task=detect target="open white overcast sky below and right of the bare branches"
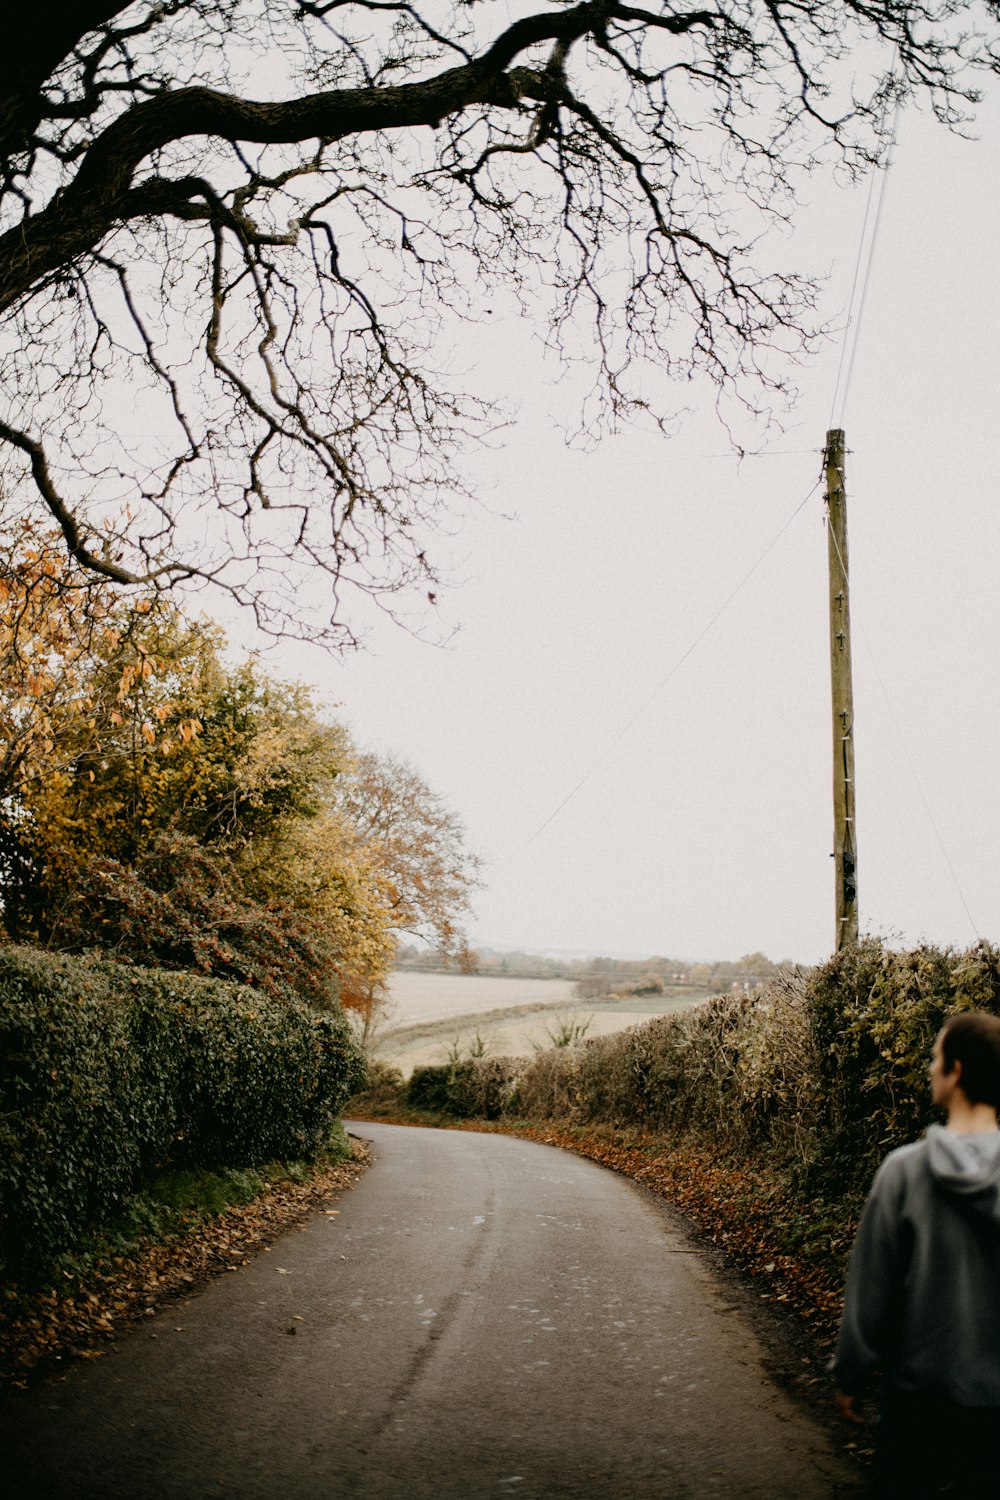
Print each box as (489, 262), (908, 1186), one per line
(230, 96), (1000, 962)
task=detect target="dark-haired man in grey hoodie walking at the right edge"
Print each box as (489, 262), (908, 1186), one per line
(832, 1011), (1000, 1500)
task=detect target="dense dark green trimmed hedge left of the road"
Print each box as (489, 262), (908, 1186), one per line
(0, 947), (364, 1274)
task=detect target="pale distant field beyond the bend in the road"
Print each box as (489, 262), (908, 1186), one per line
(373, 972), (708, 1074)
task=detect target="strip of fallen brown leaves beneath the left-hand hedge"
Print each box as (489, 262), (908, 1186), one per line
(0, 1142), (370, 1388)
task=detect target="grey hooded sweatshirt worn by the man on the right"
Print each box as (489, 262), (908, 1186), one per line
(832, 1125), (1000, 1407)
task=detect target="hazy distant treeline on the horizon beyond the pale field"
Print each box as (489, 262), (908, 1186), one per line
(396, 944), (799, 999)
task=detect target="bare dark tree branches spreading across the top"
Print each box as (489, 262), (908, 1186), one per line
(0, 0), (1000, 644)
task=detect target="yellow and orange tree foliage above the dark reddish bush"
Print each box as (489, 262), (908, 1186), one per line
(0, 527), (475, 1019)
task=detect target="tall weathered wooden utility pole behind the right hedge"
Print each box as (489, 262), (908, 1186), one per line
(826, 428), (858, 953)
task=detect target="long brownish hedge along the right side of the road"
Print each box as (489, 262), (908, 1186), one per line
(440, 939), (1000, 1203)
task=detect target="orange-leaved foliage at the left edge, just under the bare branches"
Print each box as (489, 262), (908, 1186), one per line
(0, 525), (226, 881)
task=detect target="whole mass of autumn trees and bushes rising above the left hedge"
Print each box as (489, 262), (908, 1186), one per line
(0, 531), (475, 1023)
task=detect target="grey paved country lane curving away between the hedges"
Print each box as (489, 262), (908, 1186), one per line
(0, 1125), (855, 1500)
